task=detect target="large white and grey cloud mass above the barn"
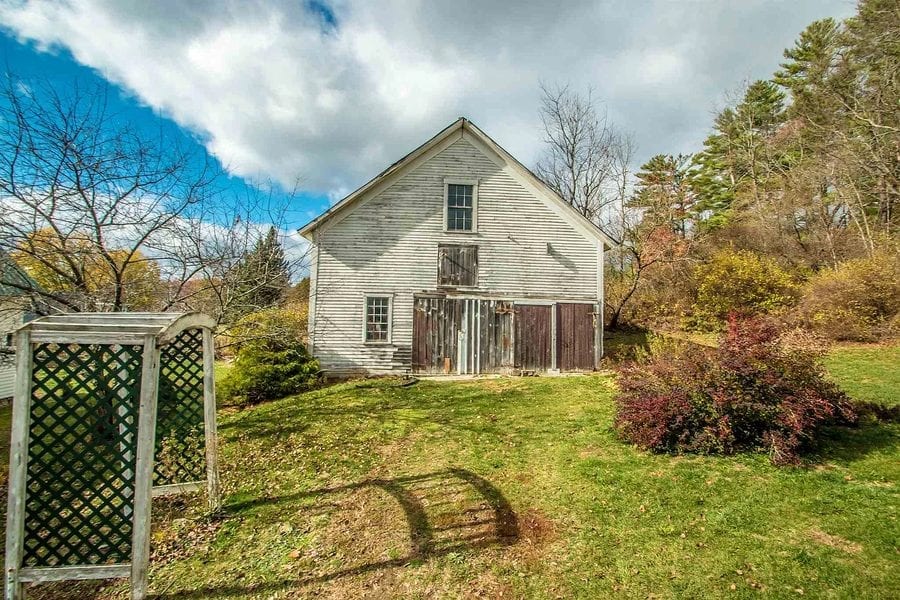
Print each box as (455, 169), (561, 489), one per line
(0, 0), (853, 197)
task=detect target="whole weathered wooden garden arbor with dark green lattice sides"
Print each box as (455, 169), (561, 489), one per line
(5, 313), (220, 600)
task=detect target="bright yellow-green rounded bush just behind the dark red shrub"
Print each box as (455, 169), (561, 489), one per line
(688, 250), (797, 331)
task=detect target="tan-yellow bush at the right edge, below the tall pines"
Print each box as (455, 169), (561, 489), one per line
(797, 252), (900, 341)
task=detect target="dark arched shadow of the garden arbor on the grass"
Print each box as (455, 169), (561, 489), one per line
(160, 468), (519, 598)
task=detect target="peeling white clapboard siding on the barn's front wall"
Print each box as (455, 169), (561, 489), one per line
(311, 134), (599, 374)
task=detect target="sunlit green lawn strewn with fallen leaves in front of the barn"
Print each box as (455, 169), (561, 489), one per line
(1, 352), (900, 598)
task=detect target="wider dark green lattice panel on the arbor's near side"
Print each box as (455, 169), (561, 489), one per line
(23, 344), (142, 566)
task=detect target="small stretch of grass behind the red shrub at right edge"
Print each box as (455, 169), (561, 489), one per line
(825, 345), (900, 406)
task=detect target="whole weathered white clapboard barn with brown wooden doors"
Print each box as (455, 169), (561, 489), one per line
(300, 118), (612, 376)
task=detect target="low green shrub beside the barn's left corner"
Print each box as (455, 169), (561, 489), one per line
(219, 308), (319, 404)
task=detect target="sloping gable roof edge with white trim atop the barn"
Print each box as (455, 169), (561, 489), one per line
(299, 117), (618, 247)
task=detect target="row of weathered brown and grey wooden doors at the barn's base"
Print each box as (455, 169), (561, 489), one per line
(412, 296), (596, 374)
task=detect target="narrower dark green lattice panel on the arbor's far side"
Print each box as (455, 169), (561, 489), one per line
(153, 329), (206, 485)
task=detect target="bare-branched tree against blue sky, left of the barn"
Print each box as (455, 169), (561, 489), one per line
(0, 76), (304, 320)
